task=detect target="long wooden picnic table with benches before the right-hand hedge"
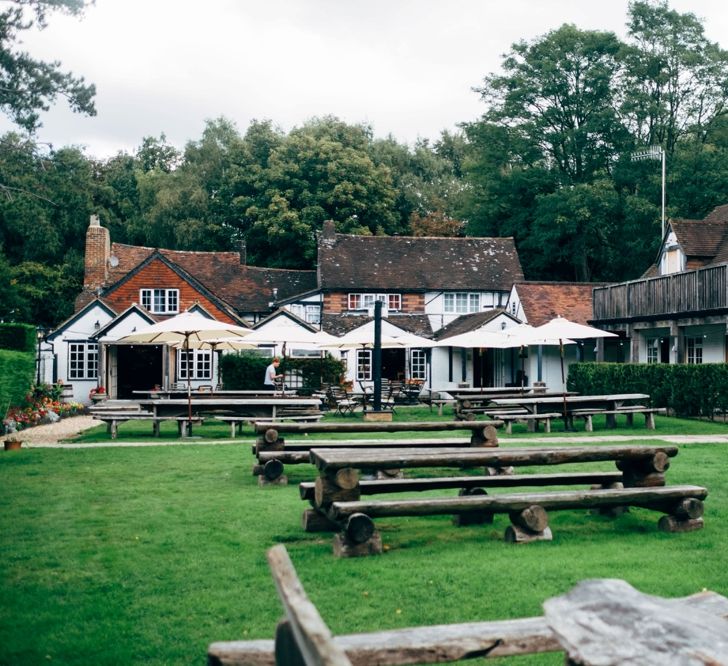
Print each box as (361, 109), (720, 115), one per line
(492, 393), (664, 431)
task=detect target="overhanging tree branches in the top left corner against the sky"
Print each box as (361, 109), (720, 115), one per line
(0, 0), (96, 132)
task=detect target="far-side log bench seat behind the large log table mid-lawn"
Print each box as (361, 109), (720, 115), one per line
(298, 472), (623, 501)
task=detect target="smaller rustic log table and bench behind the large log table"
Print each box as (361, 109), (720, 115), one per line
(253, 421), (503, 485)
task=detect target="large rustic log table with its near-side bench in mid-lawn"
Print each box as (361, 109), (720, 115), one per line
(301, 445), (707, 557)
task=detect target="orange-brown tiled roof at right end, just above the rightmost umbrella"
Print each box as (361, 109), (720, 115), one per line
(515, 282), (607, 326)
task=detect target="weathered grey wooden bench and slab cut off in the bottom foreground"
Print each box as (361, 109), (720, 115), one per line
(207, 544), (728, 666)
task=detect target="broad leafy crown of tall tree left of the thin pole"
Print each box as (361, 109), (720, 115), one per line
(477, 25), (624, 185)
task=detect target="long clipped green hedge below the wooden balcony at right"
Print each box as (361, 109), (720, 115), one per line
(568, 363), (728, 418)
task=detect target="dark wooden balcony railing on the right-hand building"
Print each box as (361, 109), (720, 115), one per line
(593, 264), (728, 322)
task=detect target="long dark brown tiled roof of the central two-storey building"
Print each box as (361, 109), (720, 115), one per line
(318, 232), (523, 291)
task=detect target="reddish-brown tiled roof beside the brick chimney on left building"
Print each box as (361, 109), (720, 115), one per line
(110, 243), (316, 314)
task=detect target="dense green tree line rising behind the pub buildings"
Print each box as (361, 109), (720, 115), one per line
(0, 0), (728, 325)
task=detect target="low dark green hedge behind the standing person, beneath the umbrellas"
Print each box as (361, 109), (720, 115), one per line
(220, 352), (345, 395)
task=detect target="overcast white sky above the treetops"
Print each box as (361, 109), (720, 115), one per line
(0, 0), (728, 157)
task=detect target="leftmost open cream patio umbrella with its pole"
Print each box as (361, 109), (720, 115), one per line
(118, 312), (250, 428)
